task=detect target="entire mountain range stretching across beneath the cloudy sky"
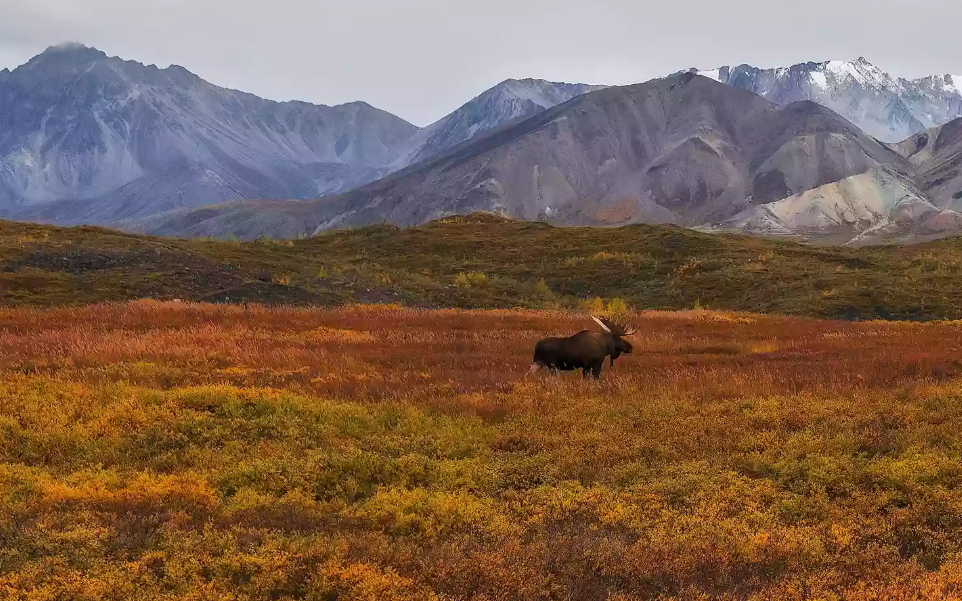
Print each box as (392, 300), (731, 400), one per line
(0, 46), (962, 244)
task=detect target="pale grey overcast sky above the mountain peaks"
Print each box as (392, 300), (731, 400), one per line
(0, 0), (962, 125)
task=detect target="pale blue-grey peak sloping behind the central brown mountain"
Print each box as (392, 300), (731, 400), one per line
(388, 79), (604, 171)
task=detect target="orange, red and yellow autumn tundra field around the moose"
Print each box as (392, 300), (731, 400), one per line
(0, 301), (962, 601)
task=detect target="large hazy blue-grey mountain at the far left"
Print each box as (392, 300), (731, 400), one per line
(0, 45), (417, 223)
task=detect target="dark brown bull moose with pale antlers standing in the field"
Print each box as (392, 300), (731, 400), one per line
(528, 316), (636, 380)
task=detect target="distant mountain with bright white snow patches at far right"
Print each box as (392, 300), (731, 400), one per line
(693, 58), (962, 142)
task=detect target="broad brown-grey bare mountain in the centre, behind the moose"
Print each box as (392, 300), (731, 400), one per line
(127, 73), (924, 240)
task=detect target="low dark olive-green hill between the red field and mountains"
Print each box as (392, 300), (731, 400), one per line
(0, 214), (962, 319)
